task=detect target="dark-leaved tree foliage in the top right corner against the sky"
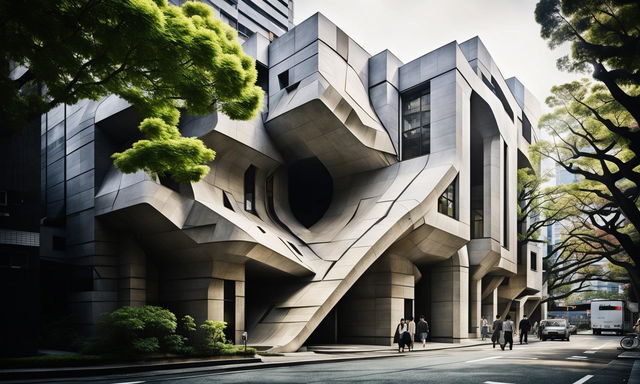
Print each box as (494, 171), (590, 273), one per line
(535, 0), (640, 147)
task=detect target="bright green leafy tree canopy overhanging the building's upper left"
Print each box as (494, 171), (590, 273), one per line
(0, 0), (263, 182)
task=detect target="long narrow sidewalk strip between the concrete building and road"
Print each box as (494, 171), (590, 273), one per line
(0, 339), (500, 380)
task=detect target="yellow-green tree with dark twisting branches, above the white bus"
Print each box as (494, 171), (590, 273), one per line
(532, 80), (640, 300)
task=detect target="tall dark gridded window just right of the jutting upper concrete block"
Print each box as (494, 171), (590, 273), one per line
(402, 86), (431, 160)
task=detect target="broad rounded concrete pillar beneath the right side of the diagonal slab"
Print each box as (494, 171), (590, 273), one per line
(337, 254), (419, 345)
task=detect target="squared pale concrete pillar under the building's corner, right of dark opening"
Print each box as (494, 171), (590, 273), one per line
(430, 247), (469, 343)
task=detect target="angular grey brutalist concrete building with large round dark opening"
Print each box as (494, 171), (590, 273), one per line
(41, 0), (543, 351)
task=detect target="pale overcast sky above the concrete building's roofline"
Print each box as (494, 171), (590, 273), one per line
(294, 0), (584, 110)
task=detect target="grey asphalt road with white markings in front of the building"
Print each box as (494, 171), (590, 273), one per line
(17, 335), (640, 384)
